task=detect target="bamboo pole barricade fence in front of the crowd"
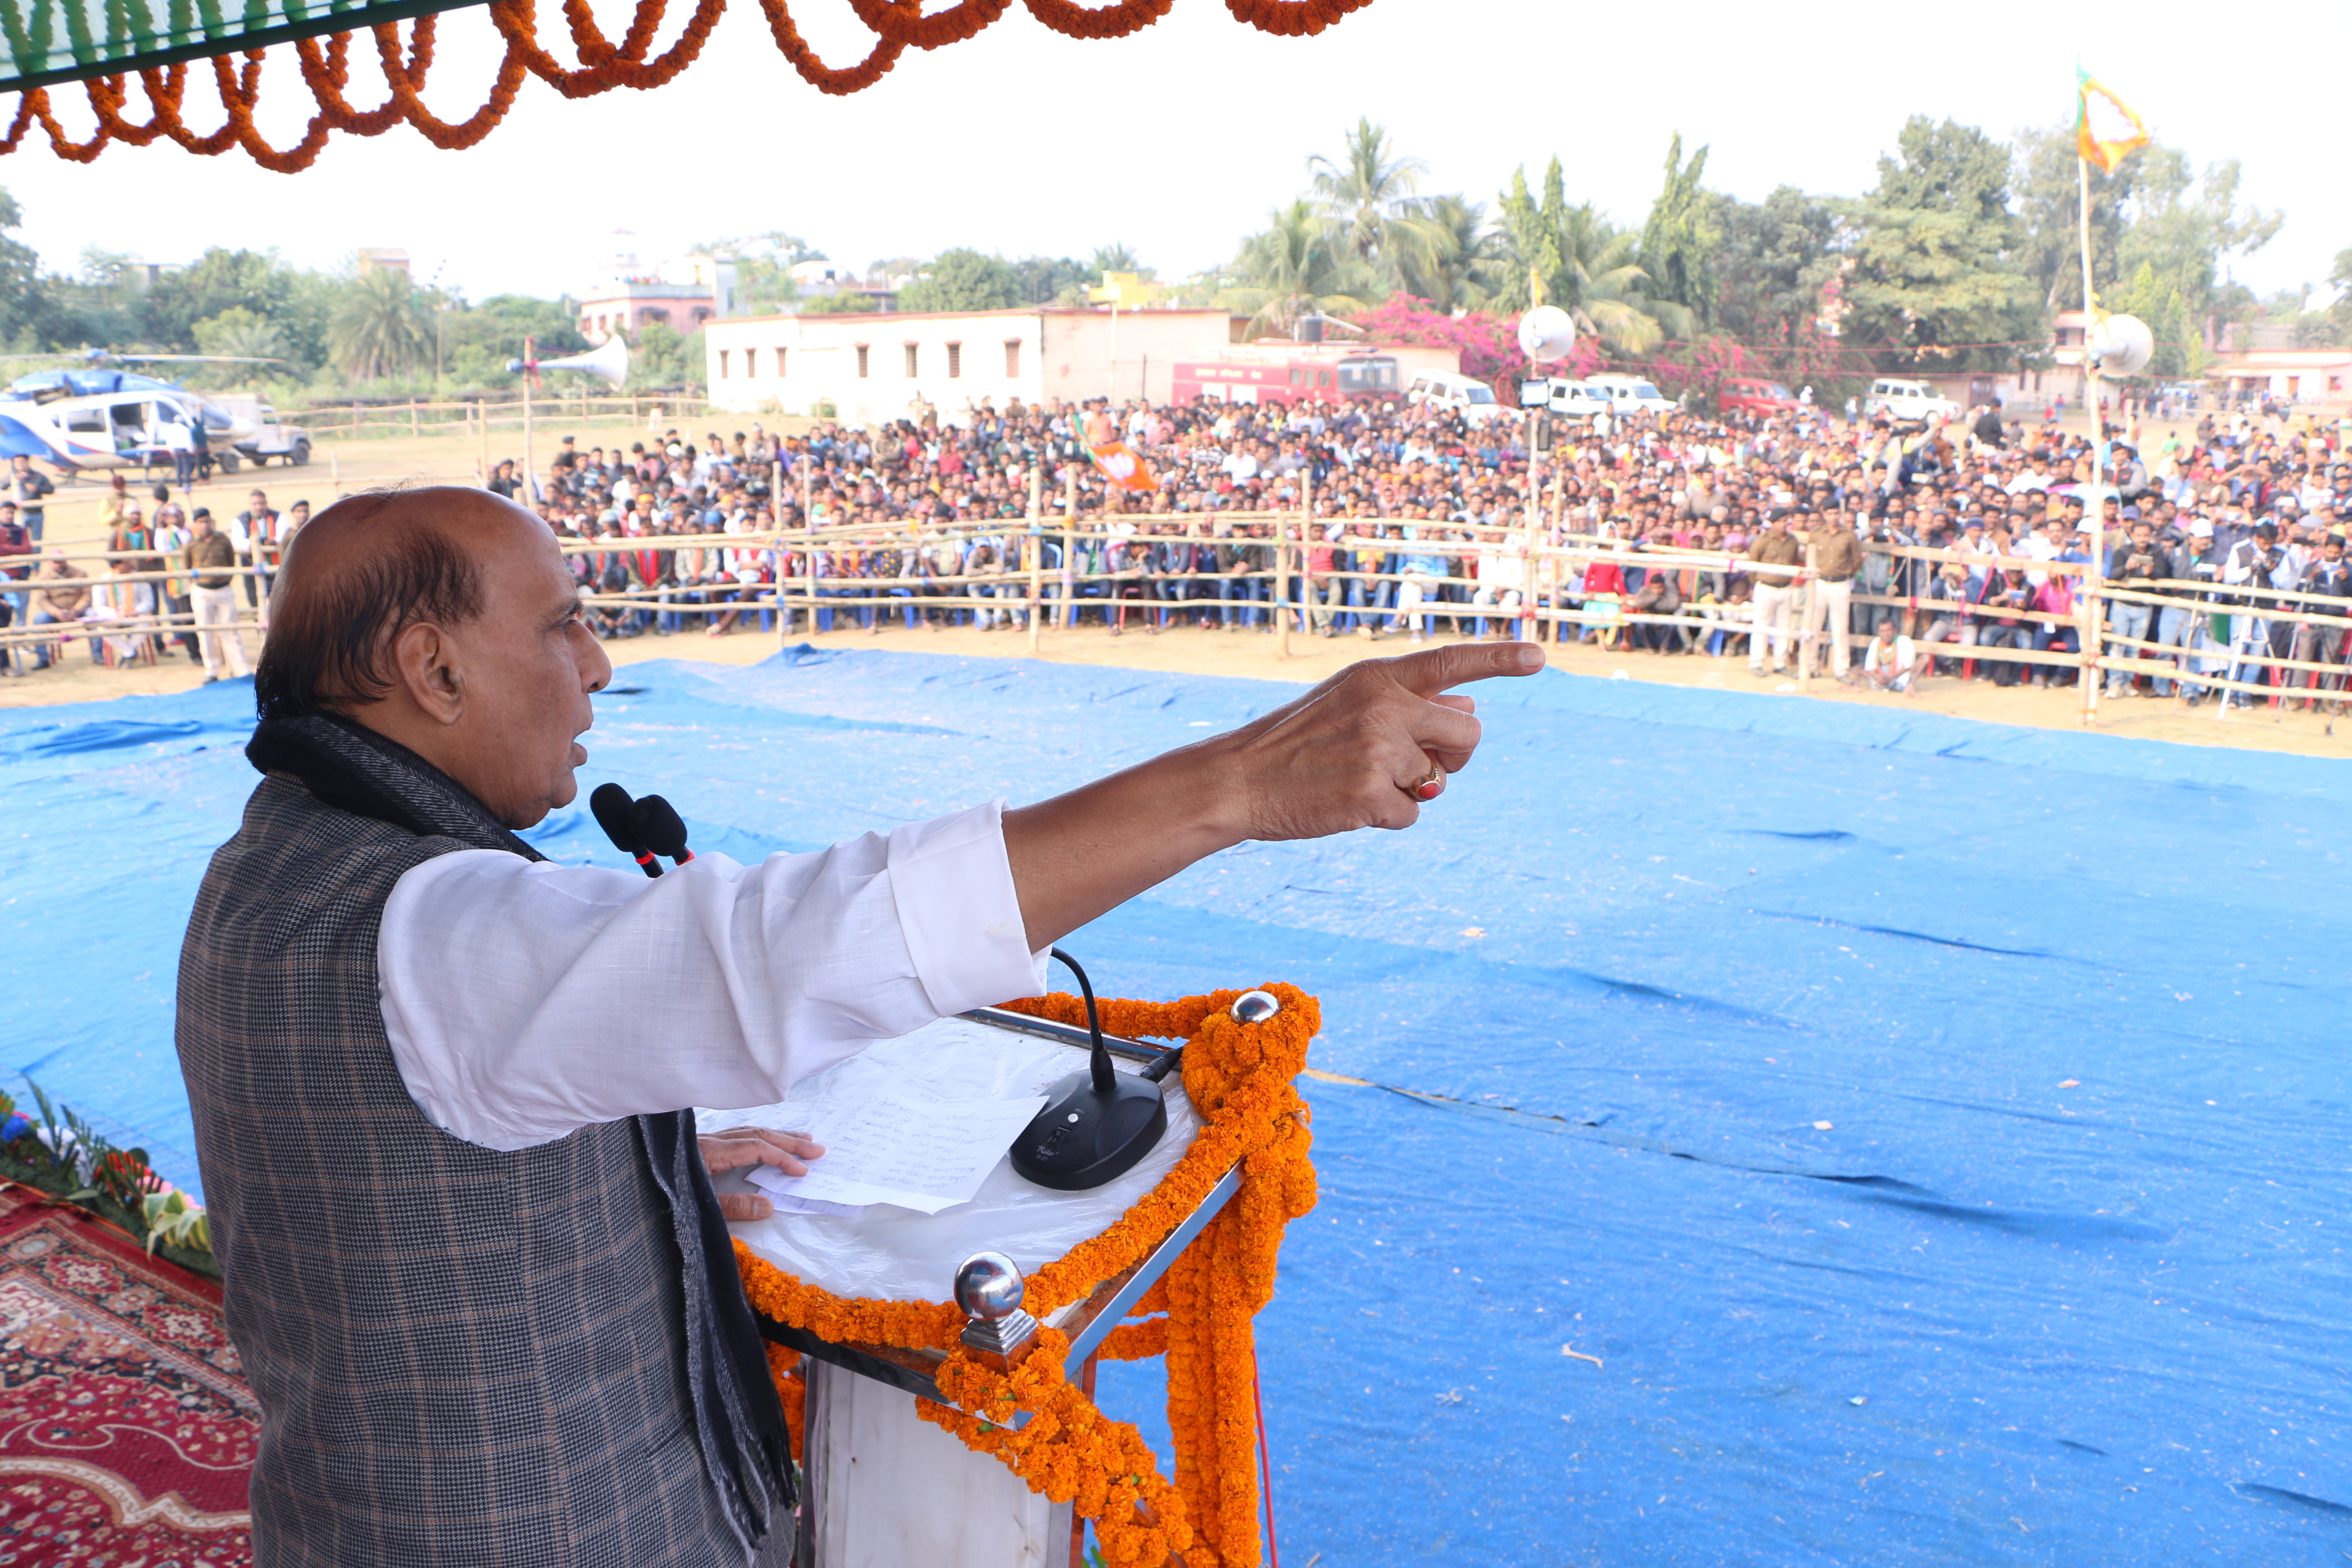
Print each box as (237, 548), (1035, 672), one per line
(18, 524), (2352, 701)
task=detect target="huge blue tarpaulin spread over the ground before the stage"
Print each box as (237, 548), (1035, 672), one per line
(0, 651), (2352, 1565)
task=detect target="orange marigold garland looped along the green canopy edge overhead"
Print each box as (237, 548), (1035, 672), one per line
(0, 0), (1371, 174)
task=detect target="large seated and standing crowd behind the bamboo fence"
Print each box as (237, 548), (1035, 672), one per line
(0, 400), (2352, 703)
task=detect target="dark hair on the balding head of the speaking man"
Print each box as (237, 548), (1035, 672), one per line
(254, 494), (482, 720)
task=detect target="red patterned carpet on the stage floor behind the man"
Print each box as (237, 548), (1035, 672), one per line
(0, 1185), (257, 1568)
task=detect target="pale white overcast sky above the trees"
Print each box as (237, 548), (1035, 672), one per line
(0, 0), (2352, 310)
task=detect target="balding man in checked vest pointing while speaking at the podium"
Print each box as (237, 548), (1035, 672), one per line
(179, 489), (1543, 1568)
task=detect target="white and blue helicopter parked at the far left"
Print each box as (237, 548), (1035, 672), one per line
(0, 348), (290, 473)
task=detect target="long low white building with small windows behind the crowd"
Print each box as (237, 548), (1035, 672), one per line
(703, 306), (1239, 426)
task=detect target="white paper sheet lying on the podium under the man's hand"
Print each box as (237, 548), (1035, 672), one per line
(750, 1095), (1044, 1213)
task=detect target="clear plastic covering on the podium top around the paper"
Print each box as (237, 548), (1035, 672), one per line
(696, 1018), (1199, 1302)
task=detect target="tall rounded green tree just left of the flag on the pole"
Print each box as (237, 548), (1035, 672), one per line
(1844, 115), (2039, 369)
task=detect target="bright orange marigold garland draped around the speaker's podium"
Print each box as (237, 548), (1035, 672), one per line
(736, 983), (1322, 1568)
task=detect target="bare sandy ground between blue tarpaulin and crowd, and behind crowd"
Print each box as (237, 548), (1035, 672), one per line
(0, 416), (2352, 757)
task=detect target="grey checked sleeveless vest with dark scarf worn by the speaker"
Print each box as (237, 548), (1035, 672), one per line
(179, 720), (792, 1568)
